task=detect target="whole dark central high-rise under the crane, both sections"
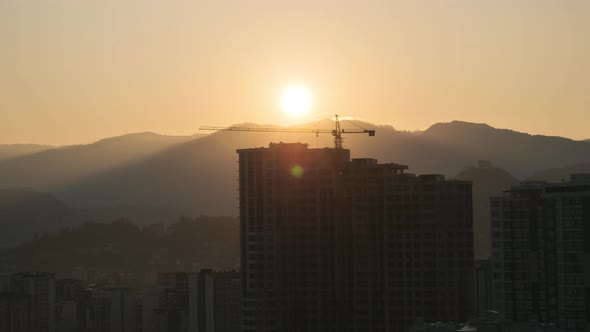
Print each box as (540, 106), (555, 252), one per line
(238, 143), (473, 331)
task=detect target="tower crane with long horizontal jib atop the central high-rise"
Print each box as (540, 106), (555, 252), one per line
(199, 114), (375, 149)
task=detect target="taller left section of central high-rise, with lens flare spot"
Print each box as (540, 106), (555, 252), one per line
(238, 144), (350, 331)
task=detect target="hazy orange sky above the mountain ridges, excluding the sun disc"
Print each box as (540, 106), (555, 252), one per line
(0, 0), (590, 144)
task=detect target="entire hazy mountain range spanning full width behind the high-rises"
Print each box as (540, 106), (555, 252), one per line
(0, 120), (590, 249)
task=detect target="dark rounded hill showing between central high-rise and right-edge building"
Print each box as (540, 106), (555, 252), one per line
(455, 161), (519, 259)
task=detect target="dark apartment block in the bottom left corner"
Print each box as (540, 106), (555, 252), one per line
(10, 272), (55, 332)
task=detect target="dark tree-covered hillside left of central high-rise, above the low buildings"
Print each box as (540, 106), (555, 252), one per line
(1, 216), (239, 272)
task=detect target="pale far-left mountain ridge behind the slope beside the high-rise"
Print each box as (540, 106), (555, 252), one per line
(0, 133), (201, 191)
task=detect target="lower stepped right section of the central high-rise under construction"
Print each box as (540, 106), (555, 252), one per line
(343, 159), (474, 331)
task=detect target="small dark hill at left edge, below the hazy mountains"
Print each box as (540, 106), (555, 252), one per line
(0, 189), (72, 246)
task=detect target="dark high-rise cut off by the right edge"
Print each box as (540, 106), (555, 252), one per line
(491, 175), (590, 331)
